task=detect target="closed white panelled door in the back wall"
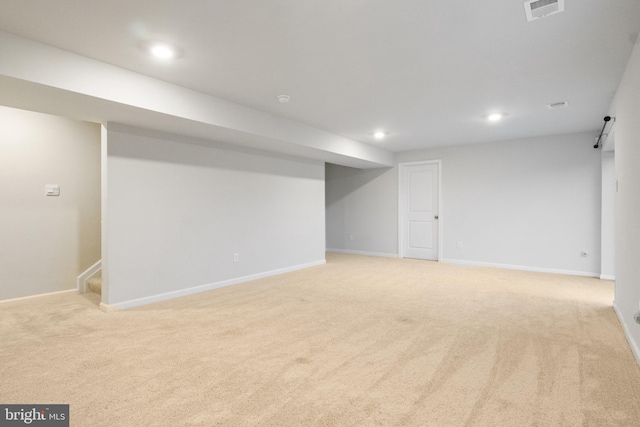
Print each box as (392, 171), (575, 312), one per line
(399, 162), (440, 261)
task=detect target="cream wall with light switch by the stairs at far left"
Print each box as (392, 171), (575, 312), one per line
(0, 107), (100, 300)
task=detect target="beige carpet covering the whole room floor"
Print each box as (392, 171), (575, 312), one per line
(0, 254), (640, 427)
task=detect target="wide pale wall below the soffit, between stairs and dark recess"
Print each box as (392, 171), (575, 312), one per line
(103, 124), (325, 307)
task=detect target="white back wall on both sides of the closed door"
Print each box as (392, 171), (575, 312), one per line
(327, 133), (601, 276)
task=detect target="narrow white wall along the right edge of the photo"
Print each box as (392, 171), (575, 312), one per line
(610, 38), (640, 363)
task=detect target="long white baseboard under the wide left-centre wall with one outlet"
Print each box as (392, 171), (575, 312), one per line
(100, 259), (327, 312)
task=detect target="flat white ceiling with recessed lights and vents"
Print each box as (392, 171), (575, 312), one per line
(0, 0), (640, 152)
